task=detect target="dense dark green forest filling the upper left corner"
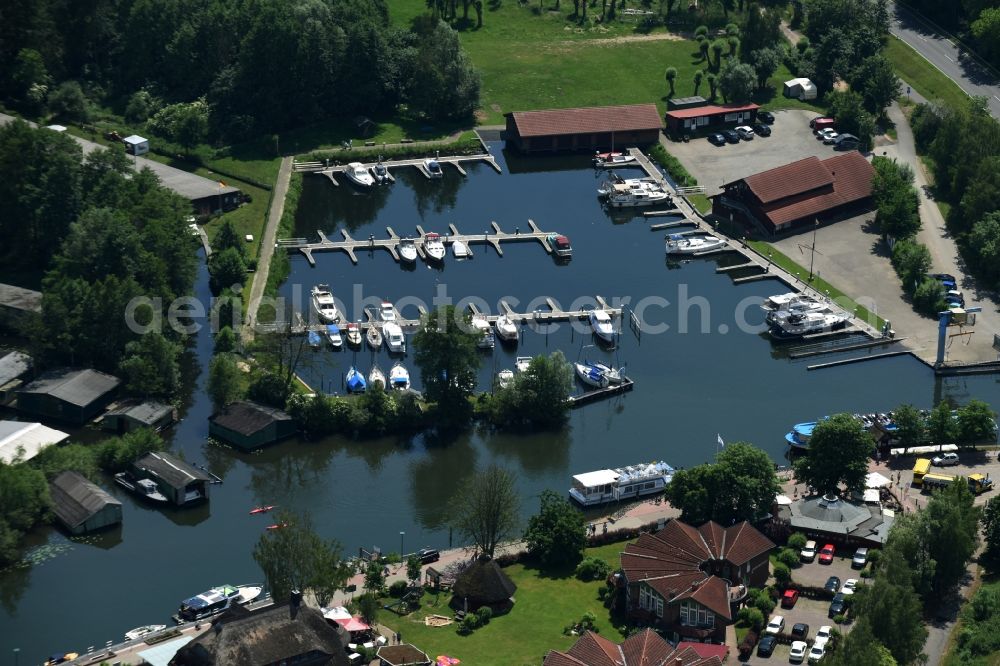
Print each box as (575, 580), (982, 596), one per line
(0, 0), (479, 140)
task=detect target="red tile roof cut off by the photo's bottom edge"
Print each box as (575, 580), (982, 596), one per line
(542, 629), (725, 666)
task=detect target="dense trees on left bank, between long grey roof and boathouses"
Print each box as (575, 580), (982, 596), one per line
(0, 121), (197, 397)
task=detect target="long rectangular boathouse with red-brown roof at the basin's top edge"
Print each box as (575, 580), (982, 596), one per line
(505, 104), (663, 153)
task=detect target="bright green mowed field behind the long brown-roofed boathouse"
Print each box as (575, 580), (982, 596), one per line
(389, 0), (814, 124)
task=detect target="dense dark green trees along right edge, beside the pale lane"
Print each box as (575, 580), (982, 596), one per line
(911, 97), (1000, 288)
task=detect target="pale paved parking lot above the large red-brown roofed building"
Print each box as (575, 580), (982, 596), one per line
(666, 110), (837, 195)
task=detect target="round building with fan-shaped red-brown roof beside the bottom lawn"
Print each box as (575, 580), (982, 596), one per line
(621, 520), (774, 643)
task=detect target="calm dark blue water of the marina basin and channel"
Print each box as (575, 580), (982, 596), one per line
(0, 146), (1000, 664)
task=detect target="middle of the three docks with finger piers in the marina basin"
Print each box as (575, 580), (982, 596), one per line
(276, 220), (559, 266)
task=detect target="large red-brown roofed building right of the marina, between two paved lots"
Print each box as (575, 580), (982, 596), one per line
(712, 151), (875, 234)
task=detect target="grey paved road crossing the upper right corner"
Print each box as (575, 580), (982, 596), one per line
(890, 4), (1000, 117)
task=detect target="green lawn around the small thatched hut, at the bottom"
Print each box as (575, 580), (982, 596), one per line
(379, 543), (625, 666)
